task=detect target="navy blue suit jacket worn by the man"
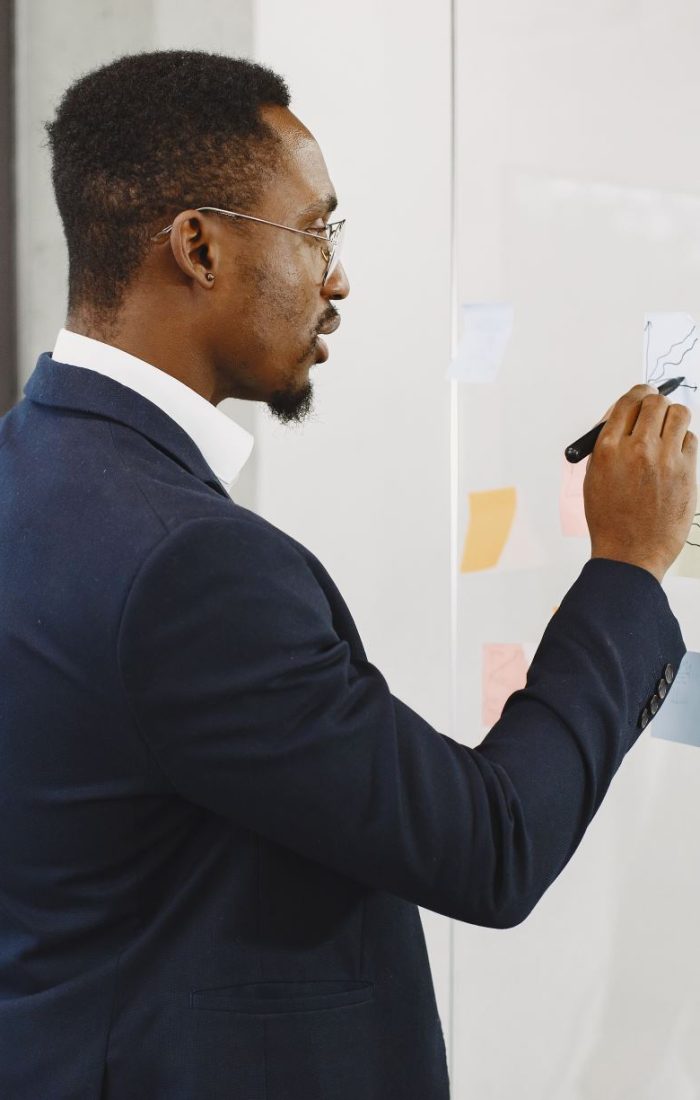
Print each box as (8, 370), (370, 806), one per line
(0, 354), (685, 1100)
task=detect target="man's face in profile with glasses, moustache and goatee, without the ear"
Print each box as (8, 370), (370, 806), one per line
(207, 107), (350, 422)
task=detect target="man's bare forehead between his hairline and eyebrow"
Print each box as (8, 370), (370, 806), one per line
(260, 107), (333, 216)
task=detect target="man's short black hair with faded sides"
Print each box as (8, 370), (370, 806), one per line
(44, 50), (289, 323)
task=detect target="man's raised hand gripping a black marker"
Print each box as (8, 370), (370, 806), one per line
(583, 385), (698, 581)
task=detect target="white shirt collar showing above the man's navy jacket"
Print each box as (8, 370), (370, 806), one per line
(52, 329), (254, 495)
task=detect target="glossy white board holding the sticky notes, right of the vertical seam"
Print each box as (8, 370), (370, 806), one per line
(450, 0), (700, 1100)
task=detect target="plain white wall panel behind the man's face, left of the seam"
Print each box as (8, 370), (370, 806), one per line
(255, 0), (451, 1069)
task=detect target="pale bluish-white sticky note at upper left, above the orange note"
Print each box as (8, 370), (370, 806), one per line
(447, 303), (513, 382)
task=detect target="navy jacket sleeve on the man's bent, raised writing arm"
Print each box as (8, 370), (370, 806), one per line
(118, 518), (685, 928)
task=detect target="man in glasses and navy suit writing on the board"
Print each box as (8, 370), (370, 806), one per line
(0, 51), (697, 1100)
